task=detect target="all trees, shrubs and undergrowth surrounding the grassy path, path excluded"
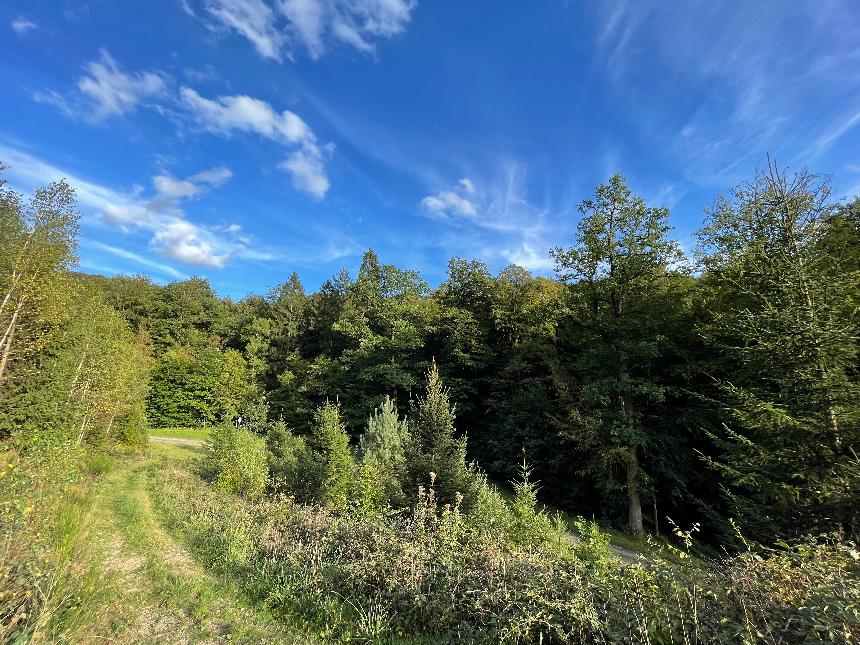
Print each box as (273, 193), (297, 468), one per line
(0, 159), (860, 643)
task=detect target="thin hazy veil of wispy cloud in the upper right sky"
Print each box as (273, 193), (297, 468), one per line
(595, 0), (860, 185)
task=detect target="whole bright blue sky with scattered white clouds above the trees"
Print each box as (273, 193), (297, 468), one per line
(0, 0), (860, 297)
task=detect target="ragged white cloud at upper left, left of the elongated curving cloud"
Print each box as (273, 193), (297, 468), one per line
(33, 49), (167, 121)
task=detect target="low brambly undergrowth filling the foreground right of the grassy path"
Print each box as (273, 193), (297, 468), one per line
(151, 458), (860, 643)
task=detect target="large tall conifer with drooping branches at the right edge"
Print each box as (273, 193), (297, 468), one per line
(699, 160), (860, 539)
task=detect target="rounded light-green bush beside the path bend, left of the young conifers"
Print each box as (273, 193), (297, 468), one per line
(209, 424), (269, 499)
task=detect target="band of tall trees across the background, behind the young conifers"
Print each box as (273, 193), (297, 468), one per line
(0, 164), (860, 544)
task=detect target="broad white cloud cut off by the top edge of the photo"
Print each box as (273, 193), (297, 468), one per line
(196, 0), (424, 61)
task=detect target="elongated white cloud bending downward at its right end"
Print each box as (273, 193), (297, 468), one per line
(179, 87), (333, 199)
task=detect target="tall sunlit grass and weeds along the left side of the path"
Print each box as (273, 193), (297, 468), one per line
(0, 446), (113, 643)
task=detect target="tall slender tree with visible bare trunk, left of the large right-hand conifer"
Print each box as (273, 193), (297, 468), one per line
(553, 175), (683, 535)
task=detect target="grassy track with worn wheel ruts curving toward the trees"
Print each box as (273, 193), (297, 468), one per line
(92, 445), (301, 643)
